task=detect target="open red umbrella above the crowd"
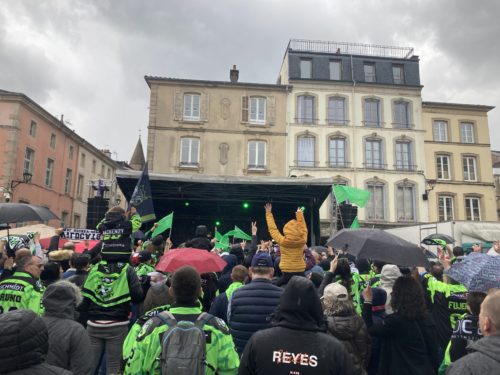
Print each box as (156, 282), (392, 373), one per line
(156, 247), (226, 273)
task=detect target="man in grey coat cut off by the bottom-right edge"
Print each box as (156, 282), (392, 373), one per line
(446, 290), (500, 375)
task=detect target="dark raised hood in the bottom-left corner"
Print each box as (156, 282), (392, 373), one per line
(0, 310), (49, 373)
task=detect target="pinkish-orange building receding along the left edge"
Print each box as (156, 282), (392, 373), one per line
(0, 90), (116, 227)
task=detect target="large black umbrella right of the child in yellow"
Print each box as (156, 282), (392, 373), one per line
(326, 228), (429, 267)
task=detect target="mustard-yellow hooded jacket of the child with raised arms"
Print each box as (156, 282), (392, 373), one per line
(266, 211), (307, 272)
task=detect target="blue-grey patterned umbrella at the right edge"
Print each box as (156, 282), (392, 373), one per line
(445, 253), (500, 293)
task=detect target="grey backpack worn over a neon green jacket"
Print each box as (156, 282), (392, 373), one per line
(156, 311), (213, 375)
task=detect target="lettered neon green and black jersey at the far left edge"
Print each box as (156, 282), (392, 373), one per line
(0, 272), (44, 315)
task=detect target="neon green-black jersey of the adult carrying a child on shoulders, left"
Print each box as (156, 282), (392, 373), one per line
(82, 260), (130, 307)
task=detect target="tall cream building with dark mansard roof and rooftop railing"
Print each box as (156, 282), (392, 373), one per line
(278, 40), (428, 231)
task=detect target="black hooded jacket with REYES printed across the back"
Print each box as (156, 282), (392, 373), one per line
(238, 276), (353, 375)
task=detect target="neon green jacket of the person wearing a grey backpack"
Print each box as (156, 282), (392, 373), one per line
(124, 307), (240, 375)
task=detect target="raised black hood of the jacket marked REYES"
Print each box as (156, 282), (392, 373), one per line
(274, 276), (325, 331)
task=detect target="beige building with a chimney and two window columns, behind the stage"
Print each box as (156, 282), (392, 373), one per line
(146, 67), (290, 177)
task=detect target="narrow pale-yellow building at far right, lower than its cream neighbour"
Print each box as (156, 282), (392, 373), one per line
(422, 102), (498, 222)
